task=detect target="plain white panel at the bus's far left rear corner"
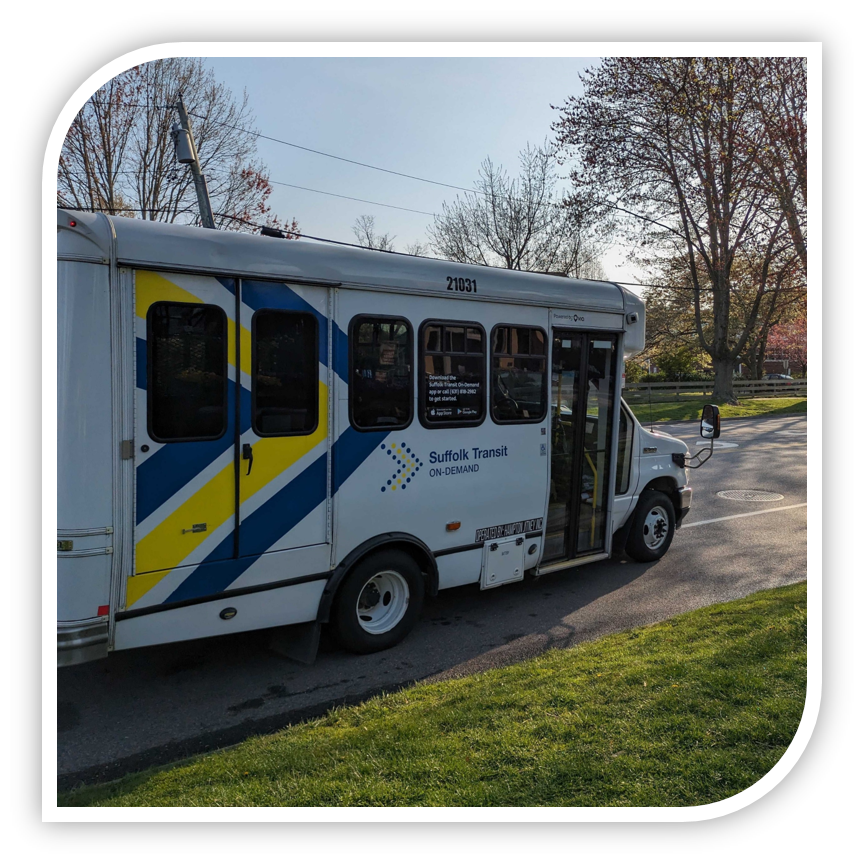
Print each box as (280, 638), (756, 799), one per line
(57, 261), (113, 621)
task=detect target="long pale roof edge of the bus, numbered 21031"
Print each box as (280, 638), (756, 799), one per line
(57, 209), (644, 318)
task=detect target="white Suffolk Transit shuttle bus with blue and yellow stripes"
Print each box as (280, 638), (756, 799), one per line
(57, 210), (719, 665)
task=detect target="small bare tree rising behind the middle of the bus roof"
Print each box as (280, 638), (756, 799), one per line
(428, 142), (602, 275)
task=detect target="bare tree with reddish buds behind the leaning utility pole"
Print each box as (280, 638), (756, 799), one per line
(57, 57), (298, 232)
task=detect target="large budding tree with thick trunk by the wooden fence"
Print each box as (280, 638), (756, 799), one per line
(554, 57), (808, 402)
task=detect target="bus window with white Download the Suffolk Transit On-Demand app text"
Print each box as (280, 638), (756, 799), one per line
(420, 321), (486, 428)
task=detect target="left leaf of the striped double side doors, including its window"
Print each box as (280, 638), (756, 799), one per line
(125, 270), (237, 608)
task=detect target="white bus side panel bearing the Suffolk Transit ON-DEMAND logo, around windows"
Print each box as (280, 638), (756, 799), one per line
(334, 289), (548, 587)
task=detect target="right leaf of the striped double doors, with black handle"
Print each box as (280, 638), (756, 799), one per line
(238, 279), (330, 556)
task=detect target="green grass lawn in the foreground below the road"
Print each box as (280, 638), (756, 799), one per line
(59, 583), (806, 807)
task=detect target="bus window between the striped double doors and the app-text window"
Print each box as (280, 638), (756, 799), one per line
(348, 315), (414, 431)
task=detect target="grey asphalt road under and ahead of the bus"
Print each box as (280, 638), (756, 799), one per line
(57, 415), (807, 788)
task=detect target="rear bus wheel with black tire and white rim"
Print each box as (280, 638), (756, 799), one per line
(330, 549), (423, 654)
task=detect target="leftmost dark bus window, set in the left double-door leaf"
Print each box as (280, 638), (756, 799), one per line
(147, 303), (228, 441)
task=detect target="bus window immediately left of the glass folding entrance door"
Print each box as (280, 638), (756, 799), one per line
(490, 324), (546, 423)
